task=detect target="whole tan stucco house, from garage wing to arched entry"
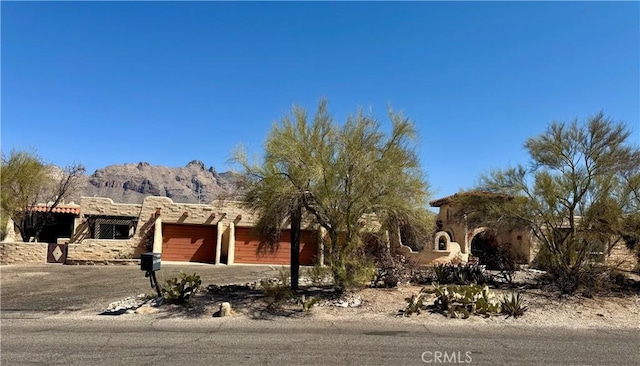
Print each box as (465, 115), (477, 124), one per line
(0, 193), (638, 269)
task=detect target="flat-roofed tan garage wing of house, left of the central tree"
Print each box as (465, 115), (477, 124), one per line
(0, 196), (322, 265)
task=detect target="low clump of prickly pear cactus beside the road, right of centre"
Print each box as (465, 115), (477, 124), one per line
(432, 284), (502, 319)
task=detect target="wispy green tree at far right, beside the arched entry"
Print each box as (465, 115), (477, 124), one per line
(470, 113), (640, 293)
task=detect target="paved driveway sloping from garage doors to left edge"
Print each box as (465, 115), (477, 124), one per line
(0, 262), (279, 318)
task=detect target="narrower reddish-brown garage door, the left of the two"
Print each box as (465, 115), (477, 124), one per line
(162, 224), (217, 263)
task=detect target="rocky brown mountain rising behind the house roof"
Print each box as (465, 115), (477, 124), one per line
(74, 160), (237, 203)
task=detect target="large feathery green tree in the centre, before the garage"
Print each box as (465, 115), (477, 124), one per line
(234, 100), (432, 289)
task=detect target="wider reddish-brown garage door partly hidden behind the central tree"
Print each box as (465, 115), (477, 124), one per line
(234, 227), (318, 266)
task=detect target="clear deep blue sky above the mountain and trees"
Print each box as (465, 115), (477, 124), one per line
(1, 1), (640, 200)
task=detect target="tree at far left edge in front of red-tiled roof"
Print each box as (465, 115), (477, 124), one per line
(0, 151), (85, 241)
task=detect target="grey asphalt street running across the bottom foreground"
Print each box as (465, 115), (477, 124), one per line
(1, 316), (640, 365)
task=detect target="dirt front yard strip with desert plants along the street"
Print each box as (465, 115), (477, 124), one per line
(160, 278), (640, 329)
